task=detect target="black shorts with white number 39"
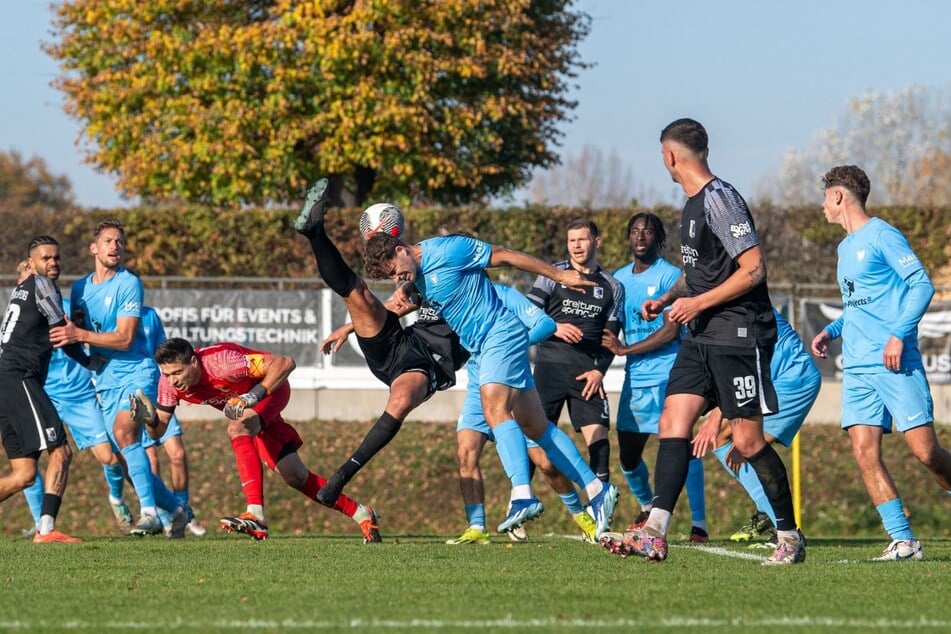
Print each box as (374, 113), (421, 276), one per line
(667, 339), (779, 419)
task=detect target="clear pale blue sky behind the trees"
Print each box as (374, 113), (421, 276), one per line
(0, 0), (951, 208)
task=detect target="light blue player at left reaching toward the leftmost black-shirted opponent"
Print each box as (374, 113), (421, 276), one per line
(50, 219), (191, 539)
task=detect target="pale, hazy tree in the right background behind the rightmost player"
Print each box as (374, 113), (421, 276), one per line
(754, 86), (951, 206)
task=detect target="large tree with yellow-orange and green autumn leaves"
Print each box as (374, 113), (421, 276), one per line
(46, 0), (590, 205)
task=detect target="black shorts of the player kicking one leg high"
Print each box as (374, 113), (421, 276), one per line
(357, 311), (439, 398)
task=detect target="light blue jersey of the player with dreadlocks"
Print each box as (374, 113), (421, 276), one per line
(614, 258), (683, 387)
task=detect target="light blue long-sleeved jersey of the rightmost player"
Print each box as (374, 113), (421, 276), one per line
(827, 218), (934, 373)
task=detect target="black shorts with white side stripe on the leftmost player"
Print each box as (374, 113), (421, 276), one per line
(0, 376), (66, 459)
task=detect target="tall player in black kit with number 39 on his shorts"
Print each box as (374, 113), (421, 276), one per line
(602, 119), (806, 564)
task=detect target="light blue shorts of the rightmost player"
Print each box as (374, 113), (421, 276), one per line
(842, 368), (934, 434)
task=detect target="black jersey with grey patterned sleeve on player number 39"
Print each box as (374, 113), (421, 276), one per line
(680, 178), (776, 347)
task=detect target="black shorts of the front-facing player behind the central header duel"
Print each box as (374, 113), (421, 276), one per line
(534, 363), (611, 431)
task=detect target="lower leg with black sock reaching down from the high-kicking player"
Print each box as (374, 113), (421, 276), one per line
(317, 371), (432, 506)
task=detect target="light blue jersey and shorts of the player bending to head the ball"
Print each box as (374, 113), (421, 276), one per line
(416, 236), (535, 390)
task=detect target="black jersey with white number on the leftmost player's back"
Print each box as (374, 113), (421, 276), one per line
(0, 275), (66, 383)
